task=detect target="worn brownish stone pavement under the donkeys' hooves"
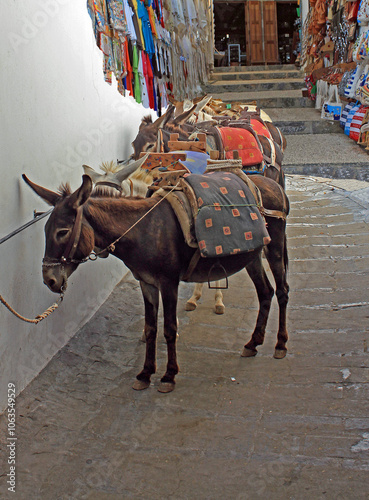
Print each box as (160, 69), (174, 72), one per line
(0, 175), (369, 500)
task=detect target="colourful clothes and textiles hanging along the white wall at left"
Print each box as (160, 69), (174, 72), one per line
(87, 0), (213, 110)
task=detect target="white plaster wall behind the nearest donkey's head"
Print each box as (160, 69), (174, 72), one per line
(0, 0), (154, 411)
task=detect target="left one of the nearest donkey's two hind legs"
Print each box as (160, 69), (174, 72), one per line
(241, 255), (274, 358)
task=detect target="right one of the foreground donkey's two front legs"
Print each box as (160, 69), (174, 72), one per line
(158, 283), (179, 392)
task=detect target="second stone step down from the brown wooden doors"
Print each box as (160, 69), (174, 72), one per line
(204, 78), (304, 94)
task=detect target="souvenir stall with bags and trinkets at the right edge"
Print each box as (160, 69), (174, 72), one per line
(301, 0), (369, 149)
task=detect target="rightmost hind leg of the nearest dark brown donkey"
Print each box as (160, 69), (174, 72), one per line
(265, 229), (289, 359)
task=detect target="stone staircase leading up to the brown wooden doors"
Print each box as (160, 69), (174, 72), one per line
(203, 64), (369, 180)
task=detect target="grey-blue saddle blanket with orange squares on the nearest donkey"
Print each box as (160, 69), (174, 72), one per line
(184, 172), (270, 257)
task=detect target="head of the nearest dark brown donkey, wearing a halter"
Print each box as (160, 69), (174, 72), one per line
(22, 174), (95, 293)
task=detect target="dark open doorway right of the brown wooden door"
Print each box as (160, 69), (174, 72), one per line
(277, 2), (299, 64)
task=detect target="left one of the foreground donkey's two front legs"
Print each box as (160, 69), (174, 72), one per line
(133, 281), (159, 391)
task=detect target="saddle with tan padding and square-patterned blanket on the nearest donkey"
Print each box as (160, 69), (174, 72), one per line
(151, 160), (270, 257)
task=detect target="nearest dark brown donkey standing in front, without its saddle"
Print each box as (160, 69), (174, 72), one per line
(23, 175), (288, 392)
